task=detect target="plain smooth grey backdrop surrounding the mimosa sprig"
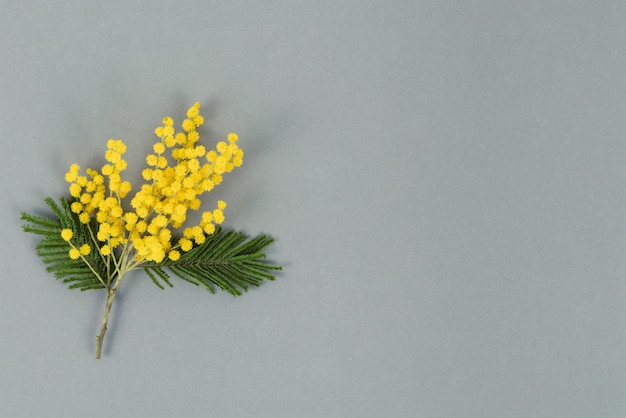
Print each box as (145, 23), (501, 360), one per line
(0, 0), (626, 417)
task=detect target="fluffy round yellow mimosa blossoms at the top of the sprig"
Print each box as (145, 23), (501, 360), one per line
(62, 103), (243, 263)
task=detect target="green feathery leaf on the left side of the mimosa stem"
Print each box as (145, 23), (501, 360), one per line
(21, 197), (106, 291)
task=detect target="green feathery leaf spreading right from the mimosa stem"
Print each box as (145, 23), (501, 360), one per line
(144, 228), (282, 296)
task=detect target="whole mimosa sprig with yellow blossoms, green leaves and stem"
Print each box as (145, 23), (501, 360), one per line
(22, 103), (281, 359)
